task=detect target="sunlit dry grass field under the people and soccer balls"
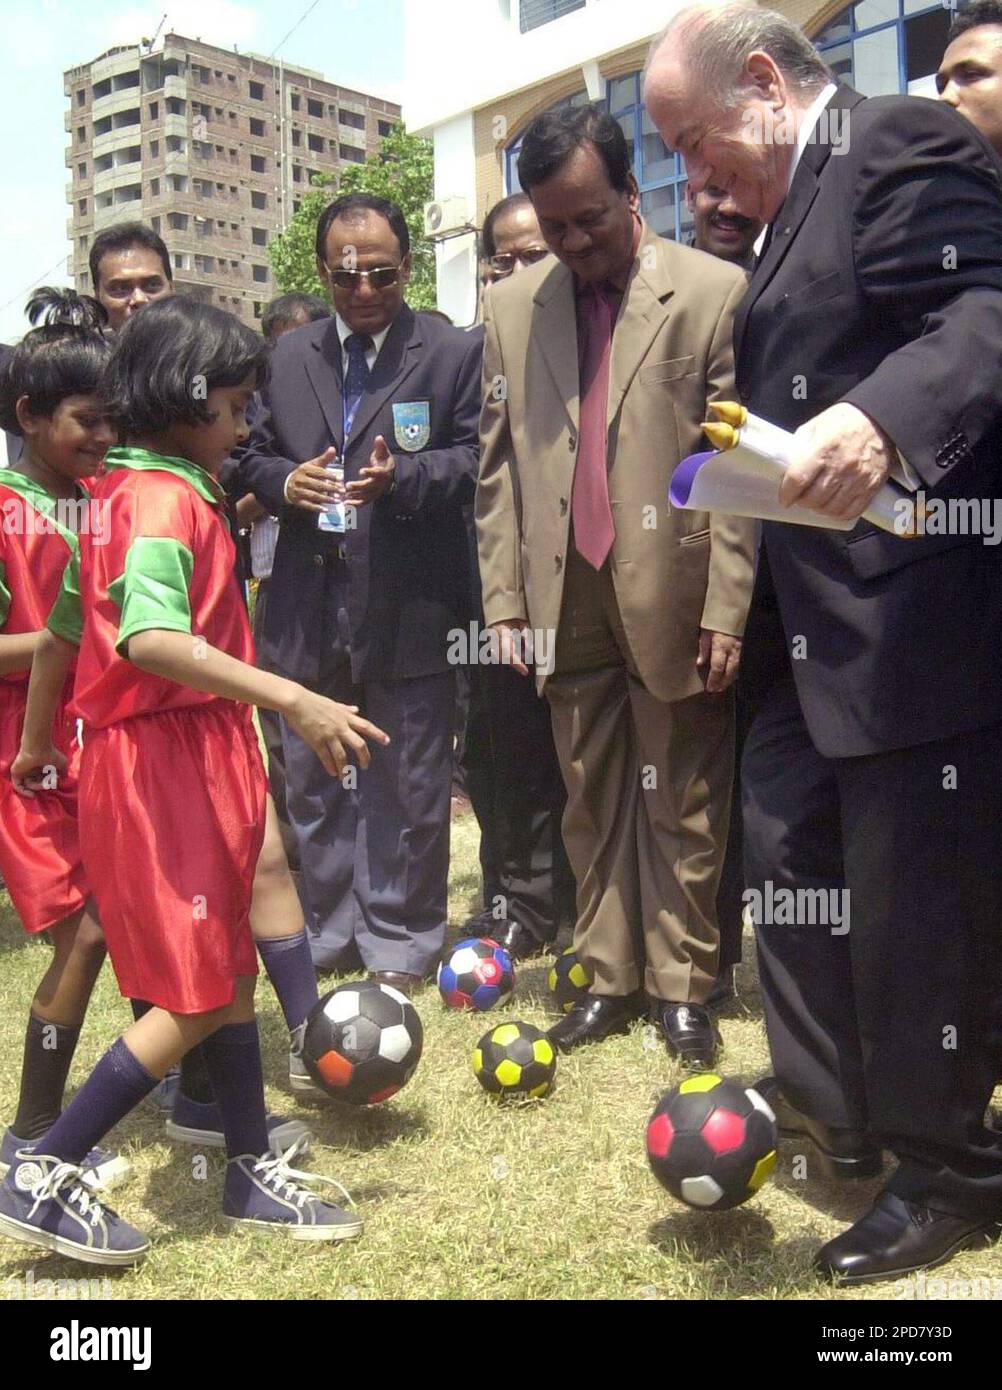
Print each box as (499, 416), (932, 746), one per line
(0, 816), (1002, 1300)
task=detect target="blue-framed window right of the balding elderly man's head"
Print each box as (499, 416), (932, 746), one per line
(814, 0), (953, 96)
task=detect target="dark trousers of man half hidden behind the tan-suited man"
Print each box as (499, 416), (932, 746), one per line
(463, 666), (575, 942)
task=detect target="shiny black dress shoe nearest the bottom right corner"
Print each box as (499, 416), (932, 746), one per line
(814, 1191), (999, 1284)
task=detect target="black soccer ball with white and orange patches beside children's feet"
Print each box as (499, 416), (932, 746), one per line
(303, 980), (424, 1105)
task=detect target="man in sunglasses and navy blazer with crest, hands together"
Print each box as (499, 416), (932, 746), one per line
(240, 193), (481, 988)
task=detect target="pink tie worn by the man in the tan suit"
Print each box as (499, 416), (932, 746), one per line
(571, 286), (616, 570)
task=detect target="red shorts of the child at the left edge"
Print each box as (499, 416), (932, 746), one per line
(0, 681), (89, 931)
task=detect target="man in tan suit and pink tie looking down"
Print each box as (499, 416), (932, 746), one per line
(477, 107), (752, 1065)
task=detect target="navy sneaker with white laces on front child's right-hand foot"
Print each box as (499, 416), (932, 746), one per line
(222, 1144), (363, 1240)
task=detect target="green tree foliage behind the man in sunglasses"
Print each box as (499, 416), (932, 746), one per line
(268, 122), (435, 309)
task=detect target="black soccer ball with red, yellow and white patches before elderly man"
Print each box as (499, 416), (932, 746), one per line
(648, 1072), (777, 1211)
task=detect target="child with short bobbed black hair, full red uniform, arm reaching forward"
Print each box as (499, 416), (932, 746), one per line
(0, 296), (388, 1265)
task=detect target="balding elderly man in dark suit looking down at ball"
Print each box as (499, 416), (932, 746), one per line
(646, 4), (1002, 1283)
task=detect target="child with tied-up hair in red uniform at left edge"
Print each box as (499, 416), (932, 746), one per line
(0, 289), (128, 1186)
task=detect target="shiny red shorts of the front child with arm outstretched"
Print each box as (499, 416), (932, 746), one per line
(81, 701), (267, 1013)
